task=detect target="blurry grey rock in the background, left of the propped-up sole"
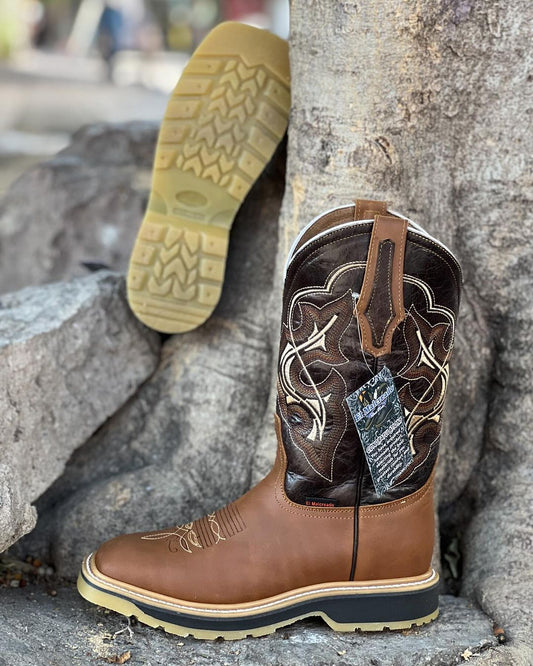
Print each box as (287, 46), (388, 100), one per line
(0, 122), (157, 293)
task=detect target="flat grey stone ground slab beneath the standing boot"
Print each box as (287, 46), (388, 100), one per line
(0, 585), (496, 666)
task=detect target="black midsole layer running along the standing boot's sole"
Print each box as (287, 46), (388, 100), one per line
(82, 573), (439, 631)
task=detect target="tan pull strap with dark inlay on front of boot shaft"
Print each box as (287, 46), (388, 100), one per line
(356, 215), (409, 357)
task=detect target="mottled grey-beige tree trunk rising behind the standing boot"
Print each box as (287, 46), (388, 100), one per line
(264, 0), (533, 663)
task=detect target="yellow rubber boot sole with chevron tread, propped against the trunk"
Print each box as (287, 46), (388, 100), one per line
(127, 23), (290, 333)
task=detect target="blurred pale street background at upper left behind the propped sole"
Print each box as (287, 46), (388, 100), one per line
(0, 0), (289, 197)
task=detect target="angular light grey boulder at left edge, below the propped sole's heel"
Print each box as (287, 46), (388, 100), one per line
(0, 272), (159, 552)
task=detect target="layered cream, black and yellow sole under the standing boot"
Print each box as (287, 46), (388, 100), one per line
(78, 556), (439, 640)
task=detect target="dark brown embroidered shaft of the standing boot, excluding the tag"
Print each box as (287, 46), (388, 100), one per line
(277, 201), (461, 506)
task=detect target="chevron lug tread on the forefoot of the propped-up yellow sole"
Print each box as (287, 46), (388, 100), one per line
(157, 56), (290, 197)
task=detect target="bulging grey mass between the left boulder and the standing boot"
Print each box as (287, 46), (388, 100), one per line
(12, 141), (284, 579)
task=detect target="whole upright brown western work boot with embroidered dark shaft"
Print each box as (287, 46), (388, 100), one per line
(78, 201), (461, 638)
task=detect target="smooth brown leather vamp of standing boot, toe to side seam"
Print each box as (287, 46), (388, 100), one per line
(95, 470), (353, 604)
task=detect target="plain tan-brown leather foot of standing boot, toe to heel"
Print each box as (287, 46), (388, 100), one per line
(95, 420), (434, 604)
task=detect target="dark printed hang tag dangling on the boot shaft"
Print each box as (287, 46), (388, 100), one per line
(346, 366), (413, 496)
